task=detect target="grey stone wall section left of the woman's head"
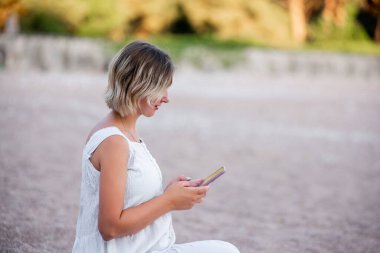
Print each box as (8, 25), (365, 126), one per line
(0, 35), (108, 72)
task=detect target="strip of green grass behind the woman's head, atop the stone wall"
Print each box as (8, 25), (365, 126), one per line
(108, 35), (380, 70)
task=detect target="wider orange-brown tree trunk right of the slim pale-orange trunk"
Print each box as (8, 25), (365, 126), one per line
(323, 0), (346, 26)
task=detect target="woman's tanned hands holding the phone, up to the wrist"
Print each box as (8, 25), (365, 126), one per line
(163, 176), (209, 210)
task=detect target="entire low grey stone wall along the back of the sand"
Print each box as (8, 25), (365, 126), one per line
(0, 35), (380, 78)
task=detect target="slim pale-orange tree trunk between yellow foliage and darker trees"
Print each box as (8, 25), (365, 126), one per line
(289, 0), (307, 43)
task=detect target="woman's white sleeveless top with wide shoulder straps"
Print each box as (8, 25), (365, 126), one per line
(72, 127), (175, 253)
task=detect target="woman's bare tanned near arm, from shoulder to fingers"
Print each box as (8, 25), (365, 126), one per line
(95, 136), (208, 240)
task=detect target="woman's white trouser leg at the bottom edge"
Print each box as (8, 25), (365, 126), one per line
(161, 240), (240, 253)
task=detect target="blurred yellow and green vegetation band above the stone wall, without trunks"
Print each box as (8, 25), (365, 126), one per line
(12, 0), (379, 55)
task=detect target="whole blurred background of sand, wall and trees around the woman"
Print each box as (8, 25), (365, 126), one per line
(0, 0), (380, 253)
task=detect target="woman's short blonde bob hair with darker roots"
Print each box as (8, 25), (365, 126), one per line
(105, 41), (174, 117)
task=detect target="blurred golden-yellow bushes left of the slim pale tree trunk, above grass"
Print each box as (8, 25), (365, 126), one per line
(15, 0), (290, 43)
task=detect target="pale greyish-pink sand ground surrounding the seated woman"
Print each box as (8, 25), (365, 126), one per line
(0, 68), (380, 253)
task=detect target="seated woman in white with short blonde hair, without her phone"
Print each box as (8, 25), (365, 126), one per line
(73, 42), (239, 253)
